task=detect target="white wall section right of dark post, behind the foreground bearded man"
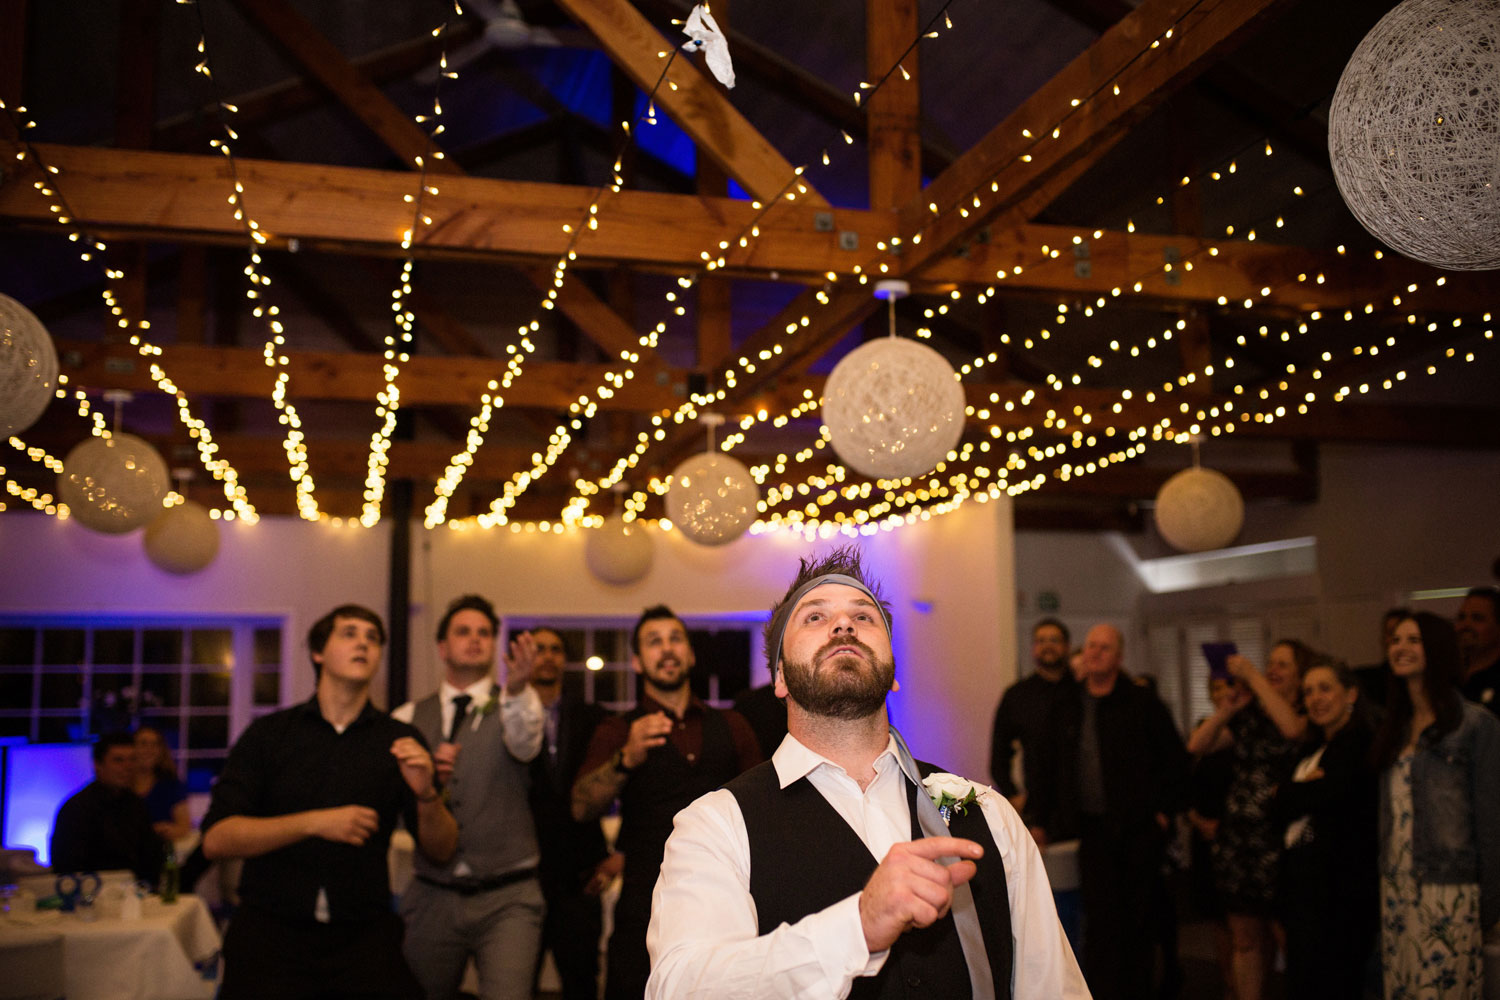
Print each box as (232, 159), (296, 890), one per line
(411, 501), (1016, 777)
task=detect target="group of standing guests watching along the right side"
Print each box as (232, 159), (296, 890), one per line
(992, 588), (1500, 1000)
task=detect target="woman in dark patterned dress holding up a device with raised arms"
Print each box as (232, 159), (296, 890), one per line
(1188, 639), (1313, 1000)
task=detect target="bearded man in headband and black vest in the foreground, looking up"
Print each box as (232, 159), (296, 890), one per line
(647, 547), (1089, 1000)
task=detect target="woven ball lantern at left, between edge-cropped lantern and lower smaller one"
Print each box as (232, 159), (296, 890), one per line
(57, 432), (170, 535)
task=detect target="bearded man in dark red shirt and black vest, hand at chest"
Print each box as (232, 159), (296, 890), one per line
(573, 604), (761, 1000)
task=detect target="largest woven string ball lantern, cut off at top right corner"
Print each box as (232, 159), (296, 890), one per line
(1328, 0), (1500, 270)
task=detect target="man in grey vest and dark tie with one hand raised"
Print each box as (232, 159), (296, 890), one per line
(392, 594), (545, 1000)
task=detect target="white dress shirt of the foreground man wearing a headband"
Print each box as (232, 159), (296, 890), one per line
(647, 736), (1089, 1000)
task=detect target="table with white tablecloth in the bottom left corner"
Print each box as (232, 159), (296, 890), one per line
(0, 895), (219, 1000)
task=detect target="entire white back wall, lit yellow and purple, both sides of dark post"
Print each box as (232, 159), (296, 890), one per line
(0, 501), (1016, 777)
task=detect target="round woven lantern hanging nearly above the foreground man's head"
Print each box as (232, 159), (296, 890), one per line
(824, 337), (965, 480)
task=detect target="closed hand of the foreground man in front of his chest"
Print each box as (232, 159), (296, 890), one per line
(860, 837), (984, 955)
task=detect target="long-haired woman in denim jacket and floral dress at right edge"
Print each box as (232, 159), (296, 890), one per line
(1374, 612), (1500, 1000)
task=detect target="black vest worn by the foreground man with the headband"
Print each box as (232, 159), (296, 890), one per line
(725, 762), (1016, 1000)
